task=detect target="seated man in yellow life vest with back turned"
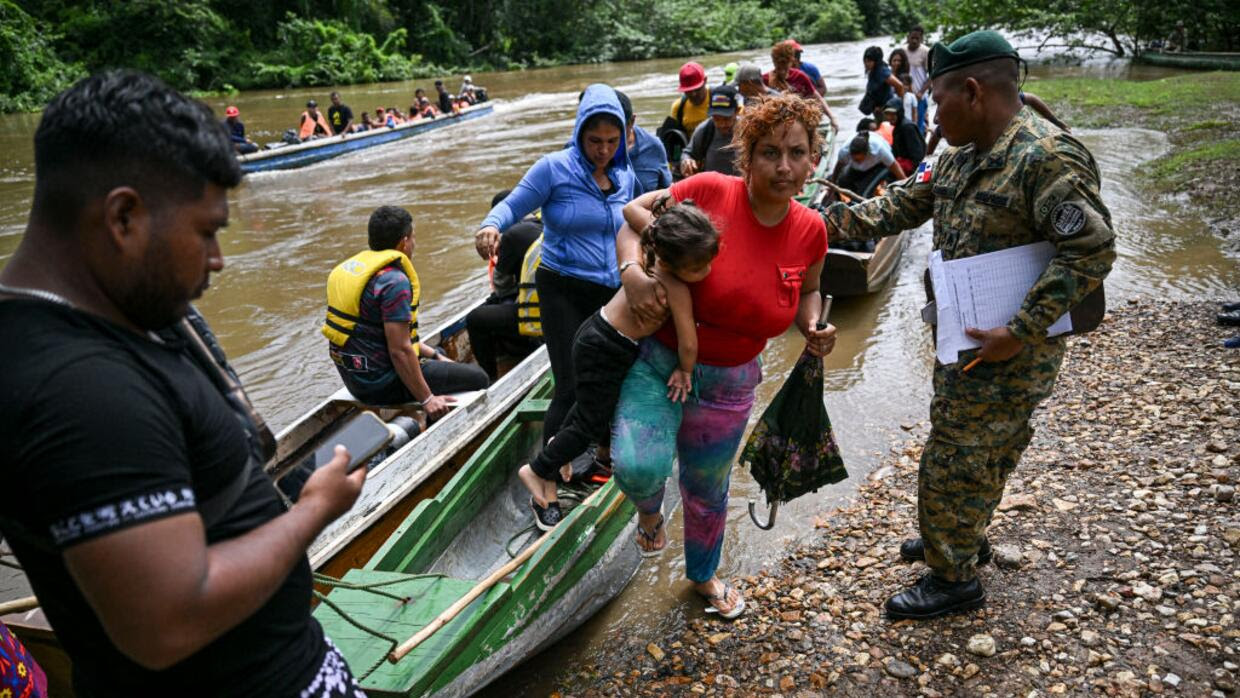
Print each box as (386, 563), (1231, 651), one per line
(322, 206), (490, 419)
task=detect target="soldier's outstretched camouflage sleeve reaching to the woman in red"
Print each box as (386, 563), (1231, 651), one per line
(822, 170), (934, 239)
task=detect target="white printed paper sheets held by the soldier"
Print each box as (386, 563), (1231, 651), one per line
(930, 242), (1073, 364)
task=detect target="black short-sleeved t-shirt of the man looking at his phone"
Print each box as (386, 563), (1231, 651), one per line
(0, 299), (325, 697)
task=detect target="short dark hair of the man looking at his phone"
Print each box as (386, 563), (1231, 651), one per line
(32, 71), (242, 231)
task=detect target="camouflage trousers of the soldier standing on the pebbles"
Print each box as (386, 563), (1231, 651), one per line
(918, 341), (1063, 581)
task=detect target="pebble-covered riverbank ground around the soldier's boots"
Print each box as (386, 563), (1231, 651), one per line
(562, 300), (1240, 698)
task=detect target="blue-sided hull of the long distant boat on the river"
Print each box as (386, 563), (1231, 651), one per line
(237, 103), (495, 174)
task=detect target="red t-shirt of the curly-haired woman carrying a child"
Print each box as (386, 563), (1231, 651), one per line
(656, 172), (827, 366)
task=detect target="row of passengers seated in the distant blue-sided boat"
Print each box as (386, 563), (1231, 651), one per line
(224, 76), (487, 155)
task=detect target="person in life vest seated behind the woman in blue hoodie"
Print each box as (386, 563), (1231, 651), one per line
(465, 190), (542, 381)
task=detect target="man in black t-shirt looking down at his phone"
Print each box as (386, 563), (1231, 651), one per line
(0, 71), (365, 698)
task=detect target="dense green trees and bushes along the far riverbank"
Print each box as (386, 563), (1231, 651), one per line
(0, 0), (1240, 112)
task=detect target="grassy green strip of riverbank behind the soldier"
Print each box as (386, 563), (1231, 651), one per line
(1025, 72), (1240, 250)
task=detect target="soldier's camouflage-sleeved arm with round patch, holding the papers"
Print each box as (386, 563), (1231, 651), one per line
(1008, 134), (1115, 343)
